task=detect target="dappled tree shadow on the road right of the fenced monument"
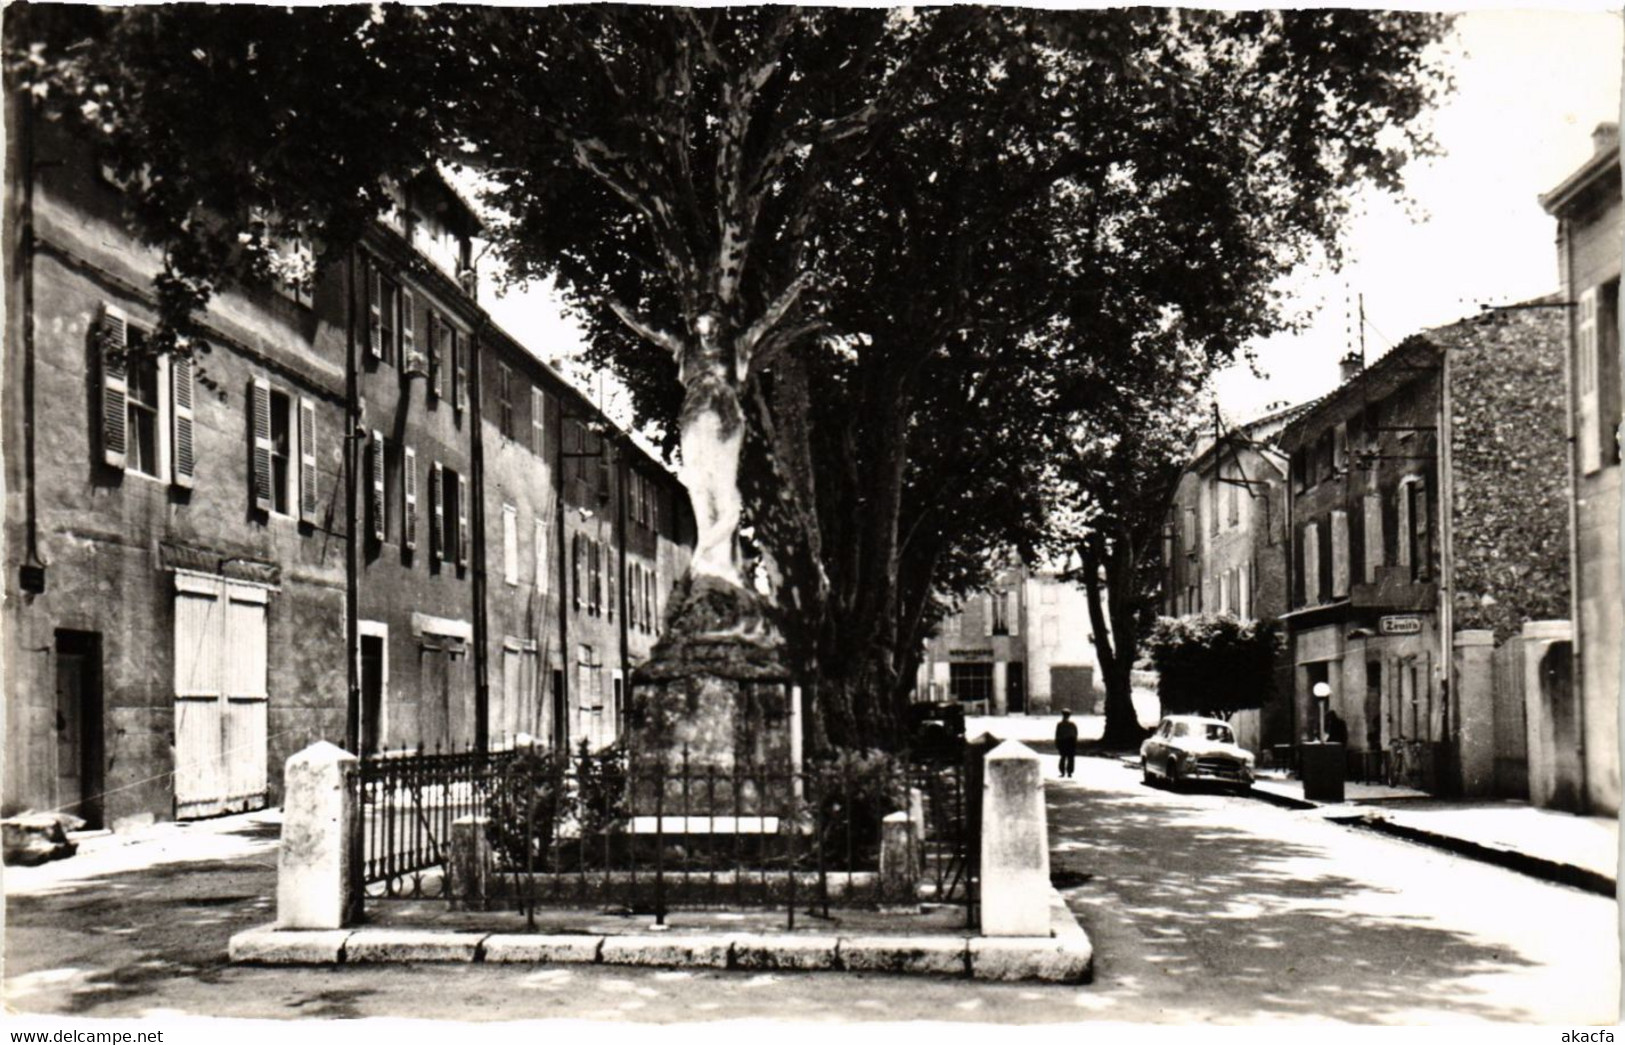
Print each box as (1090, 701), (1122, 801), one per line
(1048, 774), (1529, 1022)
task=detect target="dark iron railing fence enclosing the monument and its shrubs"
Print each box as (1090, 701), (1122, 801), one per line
(359, 748), (980, 928)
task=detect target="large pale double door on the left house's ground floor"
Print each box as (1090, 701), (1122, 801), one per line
(176, 574), (270, 819)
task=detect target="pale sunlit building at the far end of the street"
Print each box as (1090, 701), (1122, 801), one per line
(913, 566), (1103, 715)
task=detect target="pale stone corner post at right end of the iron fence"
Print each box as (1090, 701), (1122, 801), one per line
(982, 739), (1050, 936)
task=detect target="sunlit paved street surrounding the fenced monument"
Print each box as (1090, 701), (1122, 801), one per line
(5, 759), (1617, 1022)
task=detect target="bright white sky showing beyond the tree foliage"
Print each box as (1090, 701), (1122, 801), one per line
(483, 10), (1625, 424)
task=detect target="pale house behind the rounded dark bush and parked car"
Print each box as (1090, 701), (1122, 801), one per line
(1162, 405), (1308, 751)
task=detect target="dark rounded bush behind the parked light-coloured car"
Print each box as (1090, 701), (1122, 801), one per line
(1146, 613), (1285, 718)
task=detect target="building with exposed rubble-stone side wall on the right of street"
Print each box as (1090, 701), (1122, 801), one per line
(1282, 299), (1568, 793)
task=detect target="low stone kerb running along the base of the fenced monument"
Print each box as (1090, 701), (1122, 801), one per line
(229, 889), (1094, 983)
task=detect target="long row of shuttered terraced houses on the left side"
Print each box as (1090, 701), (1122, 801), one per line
(0, 99), (692, 826)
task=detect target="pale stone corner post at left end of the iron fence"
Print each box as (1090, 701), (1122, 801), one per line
(276, 739), (359, 930)
